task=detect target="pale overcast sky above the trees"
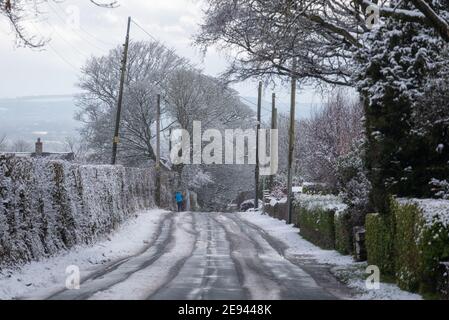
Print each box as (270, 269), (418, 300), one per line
(0, 0), (320, 107)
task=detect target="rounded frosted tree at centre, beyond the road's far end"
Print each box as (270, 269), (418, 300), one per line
(165, 68), (254, 206)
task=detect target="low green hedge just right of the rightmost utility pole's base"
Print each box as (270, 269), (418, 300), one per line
(297, 207), (335, 249)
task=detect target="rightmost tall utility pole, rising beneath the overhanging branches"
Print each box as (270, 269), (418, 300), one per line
(287, 58), (296, 224)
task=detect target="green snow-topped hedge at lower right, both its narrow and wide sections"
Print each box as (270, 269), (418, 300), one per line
(366, 199), (449, 294)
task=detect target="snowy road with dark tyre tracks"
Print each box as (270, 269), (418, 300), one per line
(47, 213), (346, 299)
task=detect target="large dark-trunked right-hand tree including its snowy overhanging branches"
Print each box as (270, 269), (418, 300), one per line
(196, 0), (449, 212)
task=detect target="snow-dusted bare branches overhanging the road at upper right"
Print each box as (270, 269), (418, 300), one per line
(196, 0), (449, 85)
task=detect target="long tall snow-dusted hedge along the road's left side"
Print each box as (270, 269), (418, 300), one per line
(0, 156), (173, 265)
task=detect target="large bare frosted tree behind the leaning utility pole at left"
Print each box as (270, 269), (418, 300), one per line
(76, 42), (187, 164)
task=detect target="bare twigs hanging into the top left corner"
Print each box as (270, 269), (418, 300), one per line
(0, 0), (118, 48)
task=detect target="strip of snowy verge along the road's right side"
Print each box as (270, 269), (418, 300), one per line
(239, 212), (422, 300)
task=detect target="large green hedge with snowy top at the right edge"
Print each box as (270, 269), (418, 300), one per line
(391, 200), (449, 294)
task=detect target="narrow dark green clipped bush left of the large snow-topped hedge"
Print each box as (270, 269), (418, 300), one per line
(365, 214), (395, 278)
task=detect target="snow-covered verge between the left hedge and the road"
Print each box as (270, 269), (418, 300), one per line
(0, 209), (168, 299)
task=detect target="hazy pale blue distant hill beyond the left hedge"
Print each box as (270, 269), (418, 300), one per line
(0, 95), (80, 151)
